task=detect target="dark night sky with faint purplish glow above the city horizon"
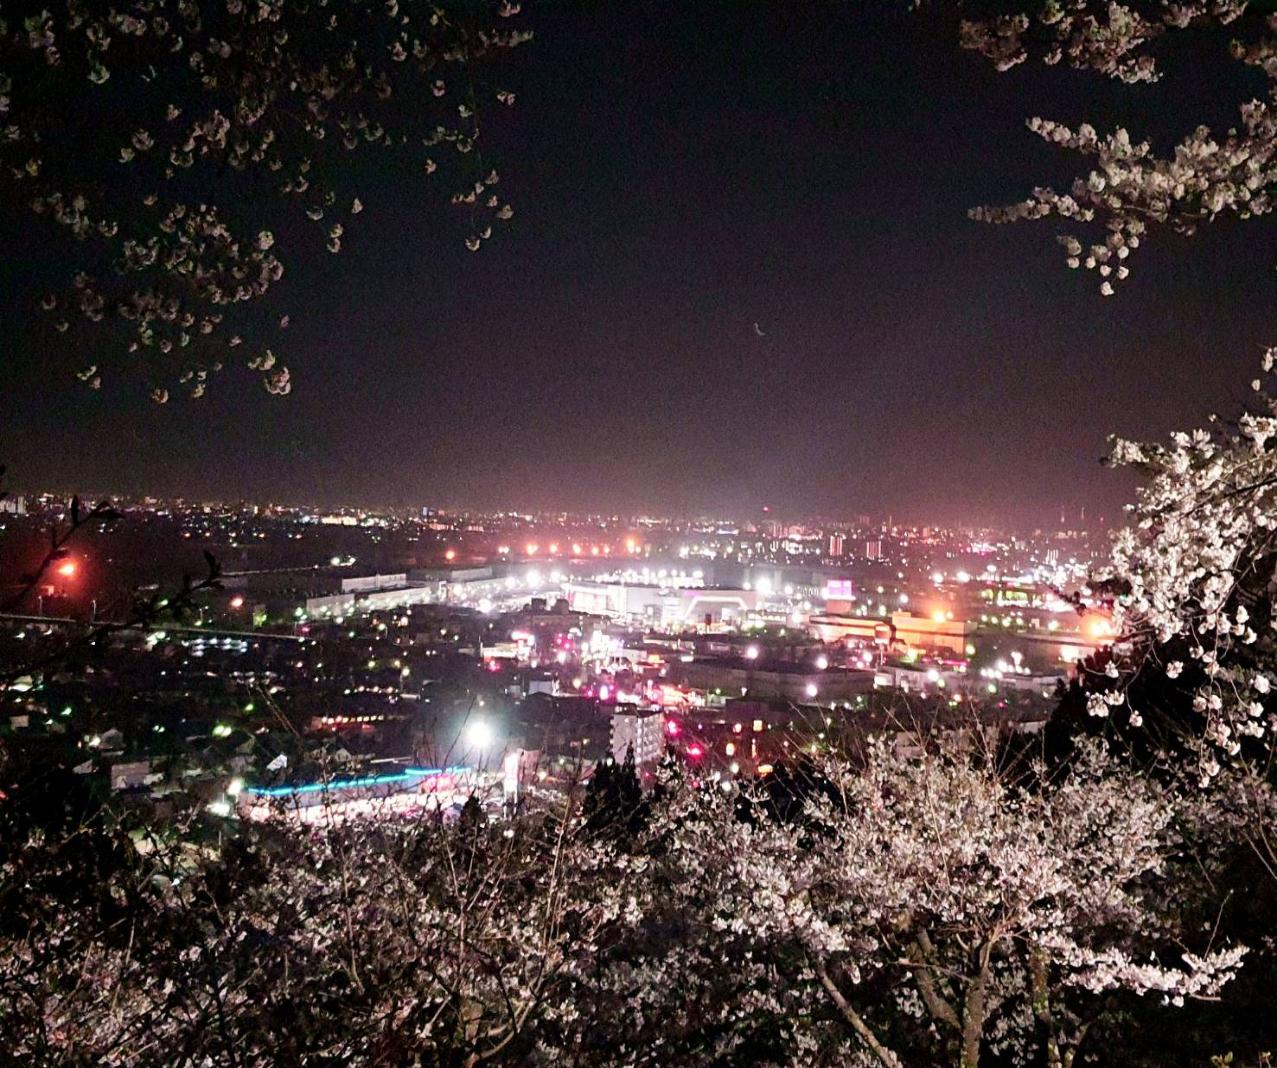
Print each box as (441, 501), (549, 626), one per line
(0, 0), (1277, 523)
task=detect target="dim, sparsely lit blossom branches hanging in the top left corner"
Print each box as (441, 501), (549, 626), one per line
(0, 0), (531, 402)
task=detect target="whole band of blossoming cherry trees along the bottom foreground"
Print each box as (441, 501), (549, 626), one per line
(0, 742), (1244, 1068)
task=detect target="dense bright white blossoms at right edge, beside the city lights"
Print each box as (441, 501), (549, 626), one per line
(1088, 350), (1277, 781)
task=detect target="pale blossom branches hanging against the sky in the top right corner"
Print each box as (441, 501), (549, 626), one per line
(962, 0), (1277, 296)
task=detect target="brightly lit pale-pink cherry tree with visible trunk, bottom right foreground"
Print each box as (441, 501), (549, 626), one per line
(572, 742), (1245, 1065)
